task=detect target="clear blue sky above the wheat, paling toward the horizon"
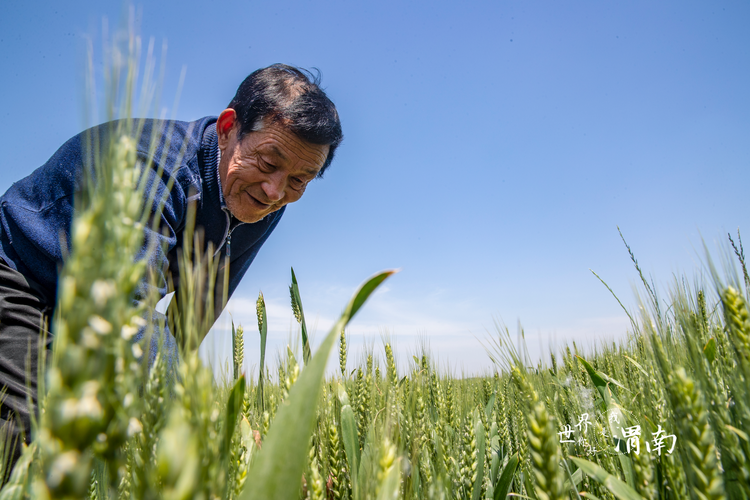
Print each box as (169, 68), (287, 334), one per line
(0, 0), (750, 373)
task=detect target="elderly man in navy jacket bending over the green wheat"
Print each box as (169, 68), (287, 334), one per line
(0, 64), (342, 462)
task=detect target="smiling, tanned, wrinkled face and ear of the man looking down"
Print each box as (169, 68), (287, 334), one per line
(216, 113), (328, 222)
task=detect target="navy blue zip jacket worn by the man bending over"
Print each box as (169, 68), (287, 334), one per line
(0, 117), (285, 356)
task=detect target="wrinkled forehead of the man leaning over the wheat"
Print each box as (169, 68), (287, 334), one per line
(242, 121), (329, 173)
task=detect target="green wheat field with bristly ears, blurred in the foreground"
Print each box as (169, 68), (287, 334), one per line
(0, 30), (750, 500)
